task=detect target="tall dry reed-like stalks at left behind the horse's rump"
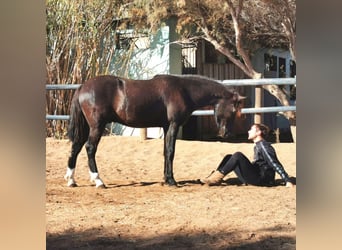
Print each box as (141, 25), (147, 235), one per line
(46, 0), (131, 137)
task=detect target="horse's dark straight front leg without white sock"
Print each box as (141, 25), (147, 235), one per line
(164, 122), (179, 186)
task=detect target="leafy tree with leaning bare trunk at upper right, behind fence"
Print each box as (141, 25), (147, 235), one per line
(131, 0), (295, 118)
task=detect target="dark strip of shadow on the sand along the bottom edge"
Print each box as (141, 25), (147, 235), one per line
(46, 226), (296, 250)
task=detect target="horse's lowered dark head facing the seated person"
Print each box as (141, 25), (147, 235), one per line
(215, 92), (246, 137)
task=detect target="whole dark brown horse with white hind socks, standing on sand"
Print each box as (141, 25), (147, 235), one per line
(65, 75), (244, 187)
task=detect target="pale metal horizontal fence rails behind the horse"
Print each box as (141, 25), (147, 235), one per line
(46, 78), (296, 120)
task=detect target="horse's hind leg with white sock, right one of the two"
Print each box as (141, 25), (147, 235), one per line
(85, 125), (105, 188)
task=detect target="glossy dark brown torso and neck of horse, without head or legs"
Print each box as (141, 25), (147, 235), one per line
(76, 75), (226, 127)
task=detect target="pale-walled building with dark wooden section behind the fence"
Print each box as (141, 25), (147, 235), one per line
(112, 19), (295, 140)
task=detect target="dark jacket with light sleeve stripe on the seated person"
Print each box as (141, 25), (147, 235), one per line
(253, 140), (290, 184)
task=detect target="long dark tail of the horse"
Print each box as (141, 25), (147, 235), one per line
(68, 88), (89, 142)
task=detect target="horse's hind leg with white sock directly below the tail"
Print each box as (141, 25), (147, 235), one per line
(64, 139), (87, 187)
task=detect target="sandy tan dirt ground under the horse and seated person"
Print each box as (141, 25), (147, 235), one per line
(46, 136), (296, 249)
